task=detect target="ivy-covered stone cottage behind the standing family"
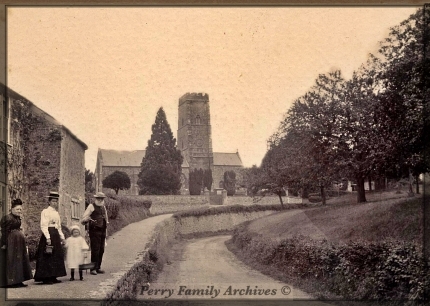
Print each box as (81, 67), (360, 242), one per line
(0, 84), (88, 235)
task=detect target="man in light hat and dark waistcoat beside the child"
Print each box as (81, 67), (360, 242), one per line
(81, 192), (109, 275)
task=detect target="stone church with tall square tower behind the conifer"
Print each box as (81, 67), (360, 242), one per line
(94, 93), (243, 195)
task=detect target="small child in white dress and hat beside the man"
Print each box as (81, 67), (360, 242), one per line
(66, 225), (89, 281)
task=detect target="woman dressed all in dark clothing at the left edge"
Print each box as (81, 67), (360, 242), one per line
(1, 199), (32, 288)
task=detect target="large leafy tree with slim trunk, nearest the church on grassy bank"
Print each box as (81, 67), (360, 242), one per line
(284, 70), (348, 203)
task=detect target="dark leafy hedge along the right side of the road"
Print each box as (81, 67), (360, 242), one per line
(232, 228), (430, 300)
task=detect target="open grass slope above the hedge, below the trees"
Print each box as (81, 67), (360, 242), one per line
(248, 198), (423, 245)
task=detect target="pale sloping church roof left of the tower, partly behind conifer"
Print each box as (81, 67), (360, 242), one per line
(99, 149), (190, 168)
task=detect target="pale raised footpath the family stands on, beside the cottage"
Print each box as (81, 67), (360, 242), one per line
(0, 214), (172, 305)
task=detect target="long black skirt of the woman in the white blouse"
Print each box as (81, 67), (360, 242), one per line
(34, 227), (67, 282)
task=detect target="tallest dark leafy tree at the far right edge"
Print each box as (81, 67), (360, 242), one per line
(376, 9), (430, 191)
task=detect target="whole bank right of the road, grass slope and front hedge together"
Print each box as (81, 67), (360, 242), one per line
(228, 192), (430, 304)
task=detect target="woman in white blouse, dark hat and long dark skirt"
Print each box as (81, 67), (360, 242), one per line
(34, 192), (67, 285)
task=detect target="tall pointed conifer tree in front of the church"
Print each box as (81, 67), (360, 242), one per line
(137, 107), (183, 195)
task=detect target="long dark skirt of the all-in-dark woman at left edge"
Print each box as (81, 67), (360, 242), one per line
(1, 230), (33, 286)
